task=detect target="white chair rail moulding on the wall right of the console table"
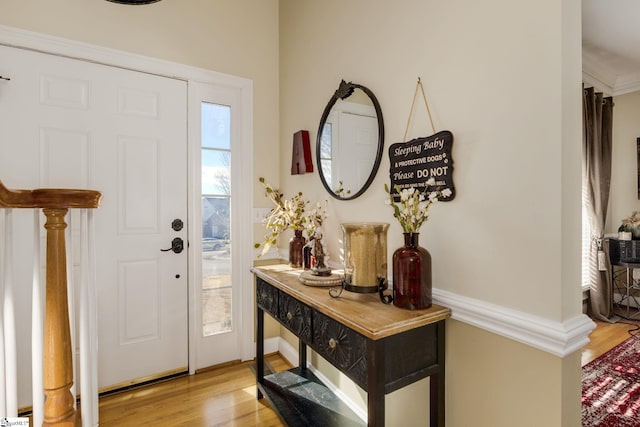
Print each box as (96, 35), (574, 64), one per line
(433, 289), (596, 357)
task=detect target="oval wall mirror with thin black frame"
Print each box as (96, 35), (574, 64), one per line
(316, 80), (384, 200)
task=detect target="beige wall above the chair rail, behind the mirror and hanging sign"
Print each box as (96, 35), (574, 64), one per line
(280, 0), (580, 320)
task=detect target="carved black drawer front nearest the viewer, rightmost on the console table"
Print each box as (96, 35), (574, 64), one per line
(313, 311), (367, 390)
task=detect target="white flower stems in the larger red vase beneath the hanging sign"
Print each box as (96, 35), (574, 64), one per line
(384, 177), (451, 233)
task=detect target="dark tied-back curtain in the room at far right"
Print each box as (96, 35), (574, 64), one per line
(582, 88), (613, 321)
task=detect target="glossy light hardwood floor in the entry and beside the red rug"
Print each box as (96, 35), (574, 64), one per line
(56, 316), (635, 427)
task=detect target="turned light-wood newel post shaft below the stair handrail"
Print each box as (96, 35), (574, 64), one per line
(42, 208), (76, 427)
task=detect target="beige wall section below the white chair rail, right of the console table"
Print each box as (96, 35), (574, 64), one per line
(446, 321), (581, 427)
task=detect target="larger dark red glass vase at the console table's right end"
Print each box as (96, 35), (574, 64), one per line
(393, 233), (432, 310)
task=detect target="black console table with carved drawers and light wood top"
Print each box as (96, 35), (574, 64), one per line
(252, 265), (450, 427)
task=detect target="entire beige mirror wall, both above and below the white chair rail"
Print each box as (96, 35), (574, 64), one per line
(280, 0), (581, 427)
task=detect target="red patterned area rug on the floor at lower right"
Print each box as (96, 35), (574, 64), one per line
(582, 335), (640, 427)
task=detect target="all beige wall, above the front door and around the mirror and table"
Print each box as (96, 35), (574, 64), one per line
(0, 0), (580, 427)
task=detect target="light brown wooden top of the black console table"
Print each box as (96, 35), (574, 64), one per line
(251, 264), (451, 340)
